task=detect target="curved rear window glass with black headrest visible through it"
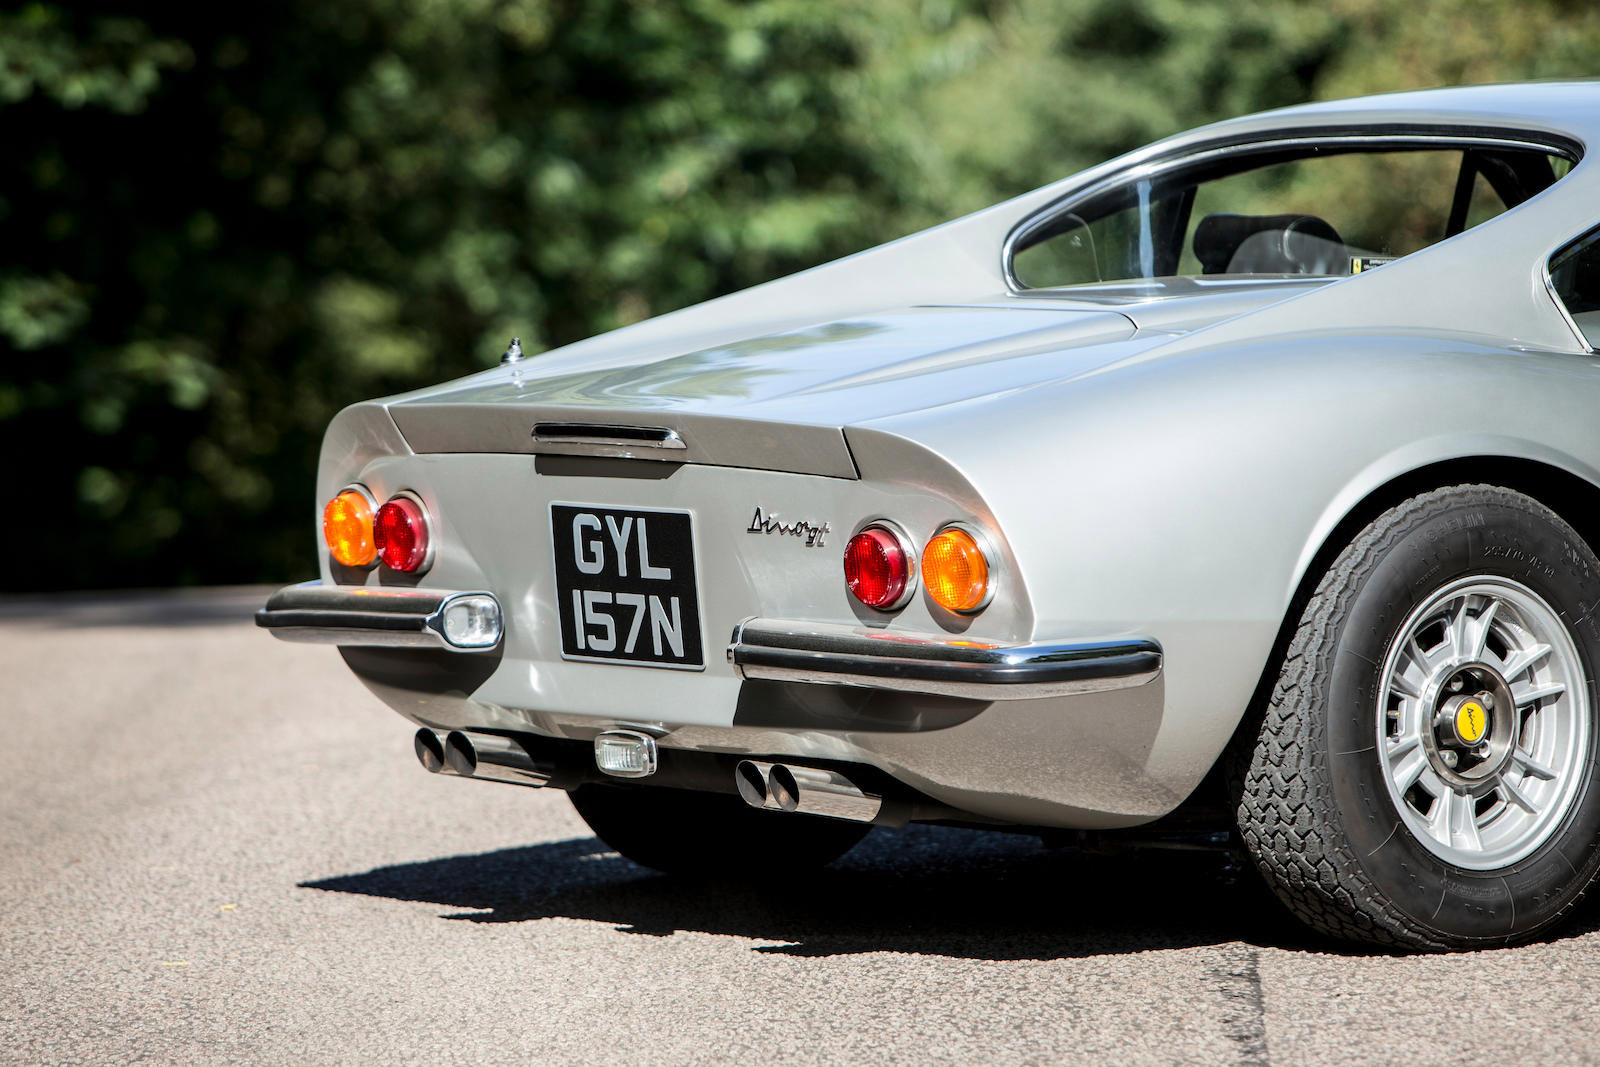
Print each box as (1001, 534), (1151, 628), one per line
(1011, 144), (1570, 290)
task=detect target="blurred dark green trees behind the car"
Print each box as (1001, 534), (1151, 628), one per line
(0, 0), (1600, 590)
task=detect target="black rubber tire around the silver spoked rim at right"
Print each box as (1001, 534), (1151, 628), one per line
(1235, 485), (1600, 950)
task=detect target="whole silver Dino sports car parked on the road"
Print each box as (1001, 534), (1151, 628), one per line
(258, 83), (1600, 949)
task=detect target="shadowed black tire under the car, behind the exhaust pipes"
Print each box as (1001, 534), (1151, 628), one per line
(570, 785), (872, 880)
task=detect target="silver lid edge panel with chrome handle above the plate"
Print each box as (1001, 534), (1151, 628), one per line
(389, 402), (861, 478)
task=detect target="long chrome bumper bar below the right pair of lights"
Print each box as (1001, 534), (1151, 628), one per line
(728, 619), (1162, 701)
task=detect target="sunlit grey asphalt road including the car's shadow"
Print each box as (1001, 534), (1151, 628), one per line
(0, 590), (1600, 1064)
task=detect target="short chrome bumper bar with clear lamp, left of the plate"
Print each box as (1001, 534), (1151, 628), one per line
(256, 581), (502, 653)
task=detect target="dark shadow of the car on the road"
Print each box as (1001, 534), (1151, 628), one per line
(301, 825), (1376, 960)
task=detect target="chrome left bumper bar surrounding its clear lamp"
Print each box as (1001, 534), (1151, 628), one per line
(256, 581), (504, 654)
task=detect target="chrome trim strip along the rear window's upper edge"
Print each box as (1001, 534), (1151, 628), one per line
(1000, 126), (1581, 296)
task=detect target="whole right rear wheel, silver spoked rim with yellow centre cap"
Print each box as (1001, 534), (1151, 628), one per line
(1237, 486), (1600, 949)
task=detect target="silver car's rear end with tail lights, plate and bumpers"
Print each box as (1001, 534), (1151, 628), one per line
(259, 402), (1173, 827)
